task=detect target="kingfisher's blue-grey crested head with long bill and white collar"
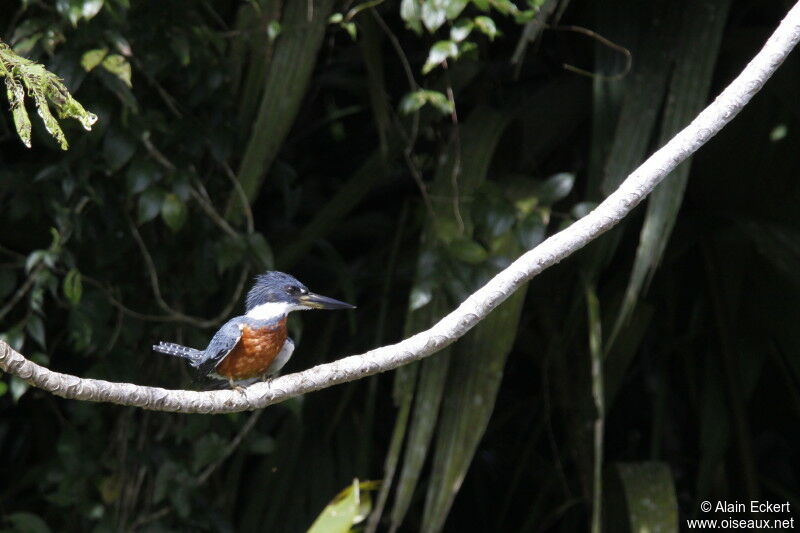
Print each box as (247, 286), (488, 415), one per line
(245, 271), (355, 320)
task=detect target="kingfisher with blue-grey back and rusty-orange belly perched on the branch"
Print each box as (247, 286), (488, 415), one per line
(153, 271), (355, 390)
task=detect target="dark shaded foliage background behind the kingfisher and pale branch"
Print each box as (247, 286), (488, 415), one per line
(0, 0), (800, 531)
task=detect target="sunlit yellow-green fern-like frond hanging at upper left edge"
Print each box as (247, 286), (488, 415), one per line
(0, 41), (97, 150)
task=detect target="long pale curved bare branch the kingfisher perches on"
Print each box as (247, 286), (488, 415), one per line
(0, 2), (800, 413)
